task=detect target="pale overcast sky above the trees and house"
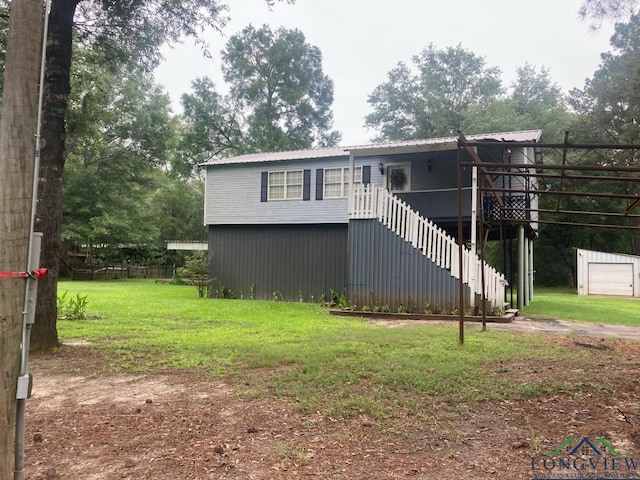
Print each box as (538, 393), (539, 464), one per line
(156, 0), (613, 145)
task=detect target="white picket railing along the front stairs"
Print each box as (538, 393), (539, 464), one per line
(349, 184), (507, 307)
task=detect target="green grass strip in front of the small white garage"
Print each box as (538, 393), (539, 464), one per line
(522, 287), (640, 326)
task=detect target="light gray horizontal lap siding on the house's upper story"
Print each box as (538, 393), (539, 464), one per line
(205, 149), (533, 225)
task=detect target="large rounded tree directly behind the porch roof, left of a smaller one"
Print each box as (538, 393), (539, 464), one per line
(366, 44), (502, 140)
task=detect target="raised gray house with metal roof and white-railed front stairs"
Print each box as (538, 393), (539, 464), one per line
(204, 130), (541, 312)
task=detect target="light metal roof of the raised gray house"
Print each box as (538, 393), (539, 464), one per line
(202, 130), (542, 166)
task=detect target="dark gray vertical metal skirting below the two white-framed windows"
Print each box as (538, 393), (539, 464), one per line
(209, 224), (347, 302)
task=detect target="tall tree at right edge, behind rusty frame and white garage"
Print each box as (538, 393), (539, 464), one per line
(536, 16), (640, 285)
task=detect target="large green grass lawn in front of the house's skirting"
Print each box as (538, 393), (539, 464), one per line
(58, 280), (639, 418)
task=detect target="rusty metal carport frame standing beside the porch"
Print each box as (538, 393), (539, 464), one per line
(457, 131), (640, 344)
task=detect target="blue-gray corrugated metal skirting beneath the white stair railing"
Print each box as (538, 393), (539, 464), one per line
(347, 220), (470, 313)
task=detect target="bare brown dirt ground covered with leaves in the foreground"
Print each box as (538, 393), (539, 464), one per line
(26, 322), (640, 480)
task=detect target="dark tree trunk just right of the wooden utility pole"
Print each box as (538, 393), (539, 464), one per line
(31, 0), (80, 351)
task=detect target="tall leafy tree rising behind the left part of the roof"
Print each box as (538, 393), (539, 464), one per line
(222, 25), (337, 152)
